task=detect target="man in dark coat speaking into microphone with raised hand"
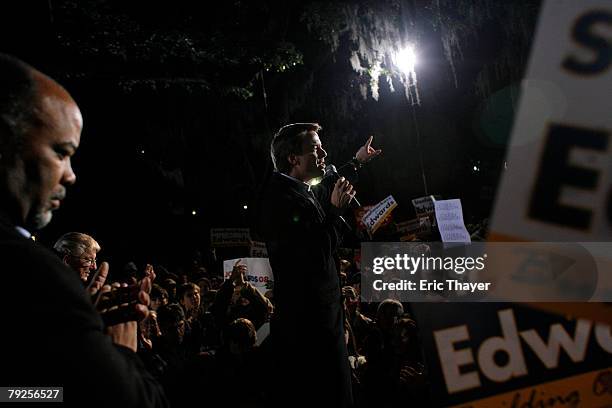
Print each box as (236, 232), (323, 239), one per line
(259, 123), (381, 407)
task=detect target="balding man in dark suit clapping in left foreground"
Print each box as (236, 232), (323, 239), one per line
(0, 54), (167, 407)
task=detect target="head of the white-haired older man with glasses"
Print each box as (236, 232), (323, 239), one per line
(53, 232), (101, 285)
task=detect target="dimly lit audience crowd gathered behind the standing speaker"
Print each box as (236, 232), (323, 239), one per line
(54, 232), (429, 407)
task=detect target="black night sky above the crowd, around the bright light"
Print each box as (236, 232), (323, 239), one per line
(0, 0), (539, 270)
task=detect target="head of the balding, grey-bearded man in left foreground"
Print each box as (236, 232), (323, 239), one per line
(0, 54), (82, 229)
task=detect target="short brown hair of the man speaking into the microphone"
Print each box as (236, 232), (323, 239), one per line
(270, 123), (322, 174)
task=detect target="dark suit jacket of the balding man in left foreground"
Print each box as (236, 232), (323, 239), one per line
(0, 216), (167, 407)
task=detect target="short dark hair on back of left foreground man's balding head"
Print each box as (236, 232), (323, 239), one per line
(0, 53), (40, 154)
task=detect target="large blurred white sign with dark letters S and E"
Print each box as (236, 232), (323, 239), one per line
(489, 0), (612, 322)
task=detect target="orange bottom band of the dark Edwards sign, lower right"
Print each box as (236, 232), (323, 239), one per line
(452, 367), (612, 408)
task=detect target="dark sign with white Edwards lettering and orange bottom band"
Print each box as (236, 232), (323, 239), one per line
(411, 303), (612, 408)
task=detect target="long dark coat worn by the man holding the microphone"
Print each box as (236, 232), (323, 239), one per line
(259, 173), (352, 407)
